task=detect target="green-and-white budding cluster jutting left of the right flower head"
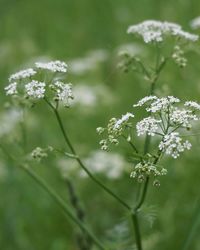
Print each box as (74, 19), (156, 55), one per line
(97, 112), (134, 150)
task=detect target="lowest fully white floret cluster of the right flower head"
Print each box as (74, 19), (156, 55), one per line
(159, 132), (192, 159)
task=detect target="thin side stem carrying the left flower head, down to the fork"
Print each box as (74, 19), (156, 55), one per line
(45, 99), (131, 211)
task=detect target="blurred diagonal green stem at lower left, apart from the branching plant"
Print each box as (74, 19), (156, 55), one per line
(21, 165), (106, 250)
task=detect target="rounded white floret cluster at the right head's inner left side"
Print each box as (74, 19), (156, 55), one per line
(136, 117), (161, 136)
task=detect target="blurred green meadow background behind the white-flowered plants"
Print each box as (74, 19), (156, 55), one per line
(0, 0), (200, 250)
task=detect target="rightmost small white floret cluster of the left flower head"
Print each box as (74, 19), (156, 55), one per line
(52, 81), (74, 106)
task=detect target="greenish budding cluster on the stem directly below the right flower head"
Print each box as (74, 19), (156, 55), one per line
(130, 161), (167, 183)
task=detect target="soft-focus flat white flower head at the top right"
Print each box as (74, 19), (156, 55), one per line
(127, 20), (199, 43)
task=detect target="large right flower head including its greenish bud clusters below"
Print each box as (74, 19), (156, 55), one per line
(97, 96), (200, 186)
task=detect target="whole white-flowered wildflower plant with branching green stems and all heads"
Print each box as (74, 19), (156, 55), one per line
(2, 20), (200, 250)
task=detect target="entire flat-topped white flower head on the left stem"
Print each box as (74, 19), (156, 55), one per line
(4, 61), (73, 107)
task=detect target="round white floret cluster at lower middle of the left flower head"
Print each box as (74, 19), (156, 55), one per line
(25, 80), (46, 99)
